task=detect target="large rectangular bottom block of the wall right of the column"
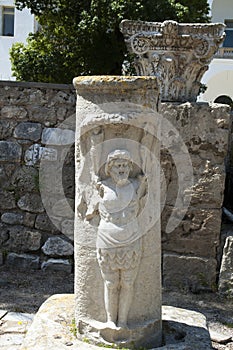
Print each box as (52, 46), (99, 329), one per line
(163, 253), (217, 292)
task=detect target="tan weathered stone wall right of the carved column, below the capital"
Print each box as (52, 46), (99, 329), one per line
(161, 102), (231, 292)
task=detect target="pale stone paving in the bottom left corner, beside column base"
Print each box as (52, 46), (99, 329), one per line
(0, 310), (34, 350)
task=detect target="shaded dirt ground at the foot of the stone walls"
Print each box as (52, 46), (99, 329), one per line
(0, 266), (233, 350)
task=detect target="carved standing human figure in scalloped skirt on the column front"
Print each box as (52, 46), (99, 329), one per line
(96, 150), (142, 327)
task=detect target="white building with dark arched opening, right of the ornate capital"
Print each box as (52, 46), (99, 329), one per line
(199, 0), (233, 103)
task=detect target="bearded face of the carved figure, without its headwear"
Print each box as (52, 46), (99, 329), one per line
(109, 159), (130, 185)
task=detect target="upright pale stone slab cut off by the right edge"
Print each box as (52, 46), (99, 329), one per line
(218, 236), (233, 296)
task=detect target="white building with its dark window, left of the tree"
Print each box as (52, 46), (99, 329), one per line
(0, 0), (36, 80)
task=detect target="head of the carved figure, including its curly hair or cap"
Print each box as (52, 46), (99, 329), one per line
(105, 150), (132, 184)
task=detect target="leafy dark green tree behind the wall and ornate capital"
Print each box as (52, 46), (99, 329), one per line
(10, 0), (209, 83)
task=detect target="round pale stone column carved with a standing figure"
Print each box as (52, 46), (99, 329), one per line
(74, 76), (162, 347)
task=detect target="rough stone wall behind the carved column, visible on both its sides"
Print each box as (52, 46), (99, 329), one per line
(0, 82), (230, 291)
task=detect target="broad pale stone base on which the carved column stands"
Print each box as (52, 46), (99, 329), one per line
(21, 294), (212, 350)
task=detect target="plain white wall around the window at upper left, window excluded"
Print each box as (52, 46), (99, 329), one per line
(0, 0), (35, 80)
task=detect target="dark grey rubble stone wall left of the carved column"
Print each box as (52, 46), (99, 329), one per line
(0, 82), (75, 272)
